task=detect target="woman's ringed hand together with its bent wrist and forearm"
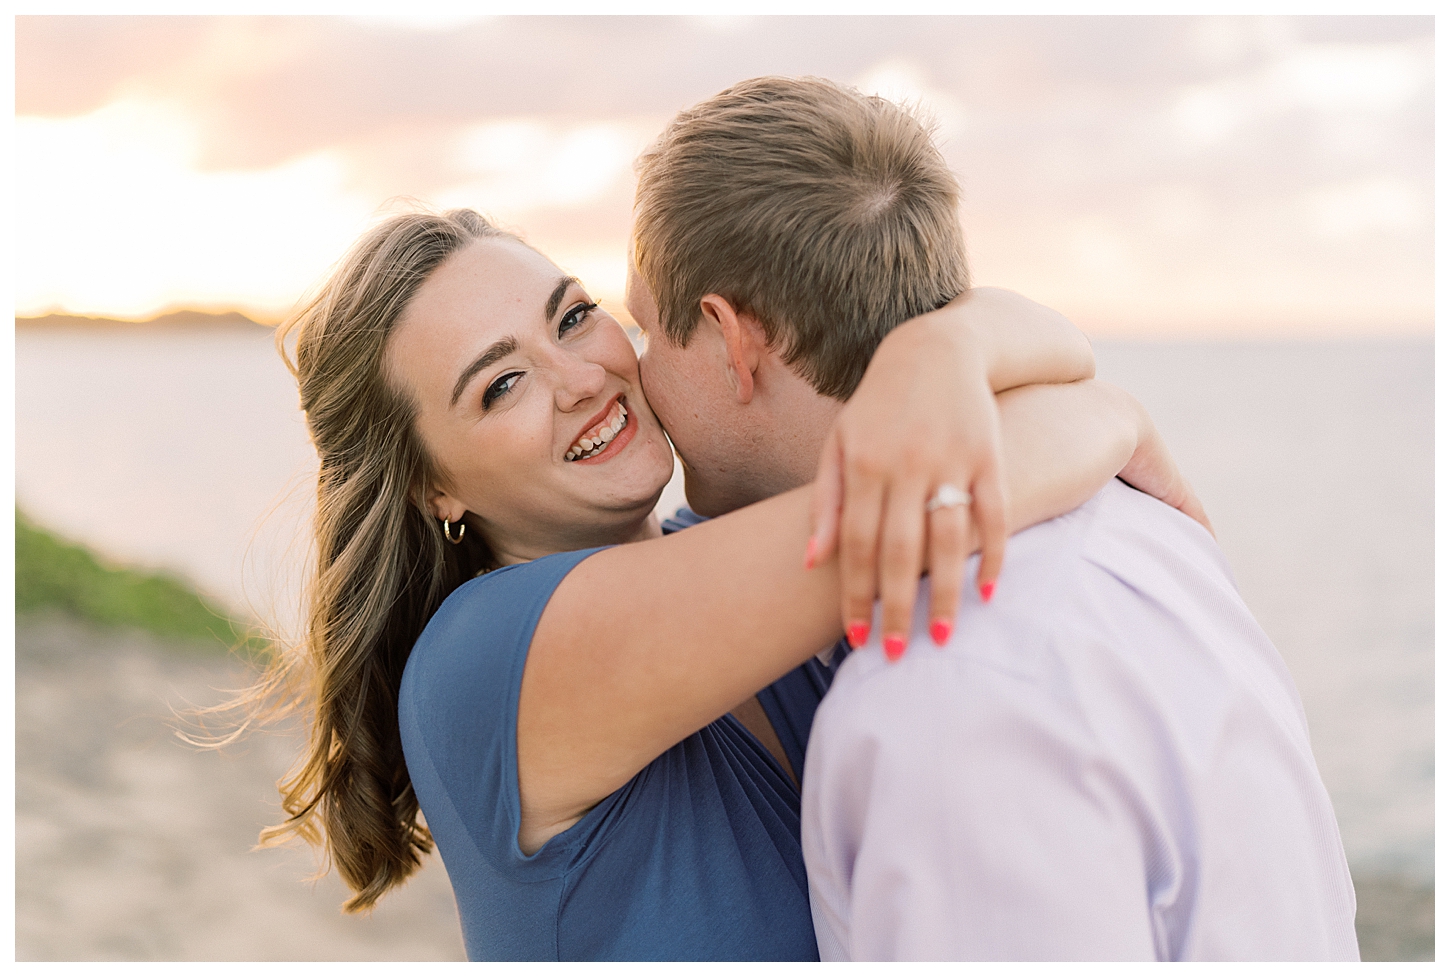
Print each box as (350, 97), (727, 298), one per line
(806, 288), (1093, 657)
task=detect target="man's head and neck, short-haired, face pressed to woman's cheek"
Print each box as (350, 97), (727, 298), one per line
(629, 78), (967, 515)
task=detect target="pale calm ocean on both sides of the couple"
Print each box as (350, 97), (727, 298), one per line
(16, 328), (1434, 883)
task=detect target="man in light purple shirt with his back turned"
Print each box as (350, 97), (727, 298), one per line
(626, 78), (1357, 960)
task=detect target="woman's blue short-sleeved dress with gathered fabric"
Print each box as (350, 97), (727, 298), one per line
(399, 512), (832, 960)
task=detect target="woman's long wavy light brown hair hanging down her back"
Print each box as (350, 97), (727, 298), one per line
(247, 210), (512, 912)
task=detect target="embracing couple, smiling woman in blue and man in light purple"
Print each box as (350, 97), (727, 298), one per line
(260, 78), (1357, 960)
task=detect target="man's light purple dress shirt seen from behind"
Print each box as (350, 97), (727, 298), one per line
(802, 481), (1359, 960)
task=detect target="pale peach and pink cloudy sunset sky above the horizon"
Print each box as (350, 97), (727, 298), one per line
(15, 16), (1434, 338)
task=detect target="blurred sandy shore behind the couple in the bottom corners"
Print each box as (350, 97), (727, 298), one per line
(16, 615), (1434, 961)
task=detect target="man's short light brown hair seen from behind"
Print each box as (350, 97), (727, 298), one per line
(634, 77), (969, 400)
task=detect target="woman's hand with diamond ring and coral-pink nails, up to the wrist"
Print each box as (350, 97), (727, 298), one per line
(806, 308), (1006, 658)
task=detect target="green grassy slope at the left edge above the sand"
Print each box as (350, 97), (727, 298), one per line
(15, 509), (261, 649)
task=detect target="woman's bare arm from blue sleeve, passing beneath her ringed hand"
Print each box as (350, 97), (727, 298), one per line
(518, 381), (1138, 851)
